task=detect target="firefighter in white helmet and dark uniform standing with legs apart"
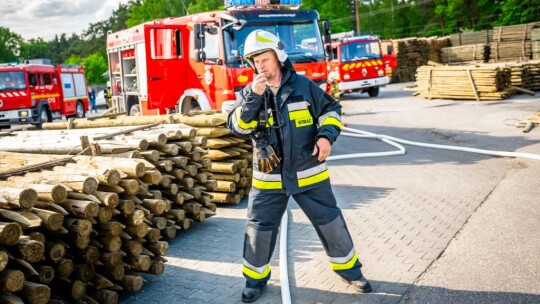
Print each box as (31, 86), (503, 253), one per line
(227, 30), (371, 303)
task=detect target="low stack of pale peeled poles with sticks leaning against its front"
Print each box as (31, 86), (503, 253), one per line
(416, 66), (514, 101)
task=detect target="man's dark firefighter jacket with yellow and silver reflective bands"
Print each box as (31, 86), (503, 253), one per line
(227, 67), (342, 195)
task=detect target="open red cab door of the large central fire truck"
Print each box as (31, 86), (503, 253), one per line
(143, 24), (189, 113)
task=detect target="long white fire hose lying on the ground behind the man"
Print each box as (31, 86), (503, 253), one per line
(279, 127), (540, 304)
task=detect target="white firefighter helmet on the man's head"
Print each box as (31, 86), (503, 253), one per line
(244, 30), (287, 67)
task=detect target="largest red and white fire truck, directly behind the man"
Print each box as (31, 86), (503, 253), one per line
(107, 0), (330, 115)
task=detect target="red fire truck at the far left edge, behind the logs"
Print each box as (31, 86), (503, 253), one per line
(0, 64), (88, 128)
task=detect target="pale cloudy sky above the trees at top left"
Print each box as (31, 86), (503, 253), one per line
(0, 0), (128, 41)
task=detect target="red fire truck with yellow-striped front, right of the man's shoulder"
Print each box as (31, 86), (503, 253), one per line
(328, 36), (392, 97)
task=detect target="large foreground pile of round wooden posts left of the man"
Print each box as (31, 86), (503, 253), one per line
(0, 115), (251, 303)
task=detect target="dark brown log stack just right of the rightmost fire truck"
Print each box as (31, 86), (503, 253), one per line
(392, 38), (450, 82)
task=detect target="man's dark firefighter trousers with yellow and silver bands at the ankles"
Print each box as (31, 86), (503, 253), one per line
(242, 184), (362, 288)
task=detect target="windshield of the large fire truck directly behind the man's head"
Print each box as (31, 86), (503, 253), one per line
(224, 21), (325, 65)
